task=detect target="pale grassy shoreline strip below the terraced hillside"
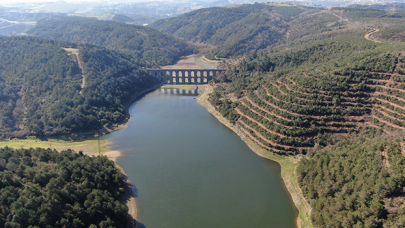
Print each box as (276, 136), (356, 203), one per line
(197, 85), (313, 228)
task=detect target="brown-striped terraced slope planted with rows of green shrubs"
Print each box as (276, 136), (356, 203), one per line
(211, 54), (405, 154)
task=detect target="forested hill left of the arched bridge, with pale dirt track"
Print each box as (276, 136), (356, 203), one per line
(0, 37), (158, 138)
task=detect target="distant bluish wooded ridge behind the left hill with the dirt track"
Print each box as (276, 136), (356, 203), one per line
(27, 16), (194, 65)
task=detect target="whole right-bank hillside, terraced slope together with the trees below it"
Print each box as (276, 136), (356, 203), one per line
(205, 5), (405, 227)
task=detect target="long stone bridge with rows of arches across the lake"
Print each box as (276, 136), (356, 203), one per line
(146, 69), (226, 84)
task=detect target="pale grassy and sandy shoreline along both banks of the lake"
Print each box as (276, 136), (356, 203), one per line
(0, 84), (313, 228)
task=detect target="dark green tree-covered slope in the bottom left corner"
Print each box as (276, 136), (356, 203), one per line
(0, 147), (130, 228)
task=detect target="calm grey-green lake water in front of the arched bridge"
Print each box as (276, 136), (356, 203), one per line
(103, 89), (297, 228)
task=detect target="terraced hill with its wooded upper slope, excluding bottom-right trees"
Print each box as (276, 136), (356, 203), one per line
(210, 7), (405, 157)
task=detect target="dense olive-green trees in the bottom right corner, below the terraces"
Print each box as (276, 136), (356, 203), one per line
(297, 137), (405, 227)
